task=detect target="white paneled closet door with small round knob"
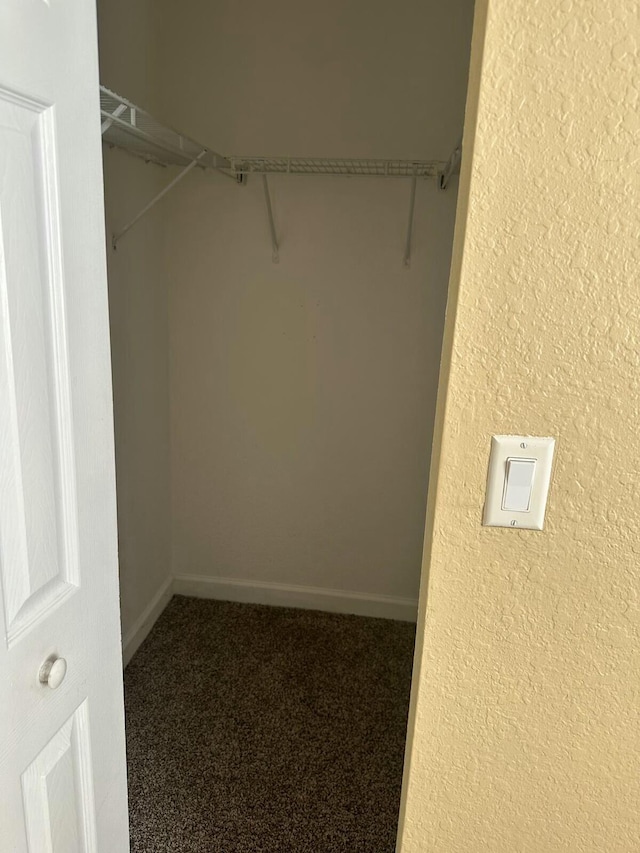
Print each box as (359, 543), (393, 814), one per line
(0, 0), (129, 853)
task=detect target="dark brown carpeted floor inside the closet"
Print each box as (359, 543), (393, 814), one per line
(125, 596), (414, 853)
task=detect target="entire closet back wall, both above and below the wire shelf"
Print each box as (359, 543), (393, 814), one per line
(159, 0), (472, 616)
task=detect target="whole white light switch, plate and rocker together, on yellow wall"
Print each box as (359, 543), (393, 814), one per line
(482, 435), (555, 530)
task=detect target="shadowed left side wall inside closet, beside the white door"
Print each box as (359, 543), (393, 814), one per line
(98, 0), (171, 640)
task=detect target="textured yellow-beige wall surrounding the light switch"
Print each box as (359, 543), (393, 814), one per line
(401, 0), (640, 853)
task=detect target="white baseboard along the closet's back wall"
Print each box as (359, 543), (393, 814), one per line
(173, 575), (418, 622)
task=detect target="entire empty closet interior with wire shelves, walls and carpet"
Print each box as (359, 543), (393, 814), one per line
(98, 0), (473, 853)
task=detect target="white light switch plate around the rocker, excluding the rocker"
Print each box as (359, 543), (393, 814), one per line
(482, 435), (556, 530)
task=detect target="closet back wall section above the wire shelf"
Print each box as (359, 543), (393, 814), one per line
(156, 0), (473, 159)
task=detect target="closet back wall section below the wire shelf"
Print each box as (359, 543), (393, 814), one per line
(167, 170), (455, 604)
